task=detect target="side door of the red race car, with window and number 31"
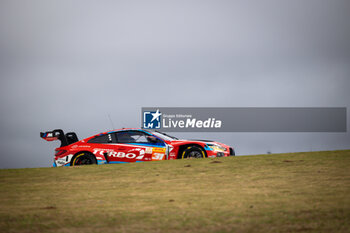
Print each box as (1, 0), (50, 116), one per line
(109, 130), (166, 163)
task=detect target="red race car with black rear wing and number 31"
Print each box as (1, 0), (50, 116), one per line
(40, 128), (235, 167)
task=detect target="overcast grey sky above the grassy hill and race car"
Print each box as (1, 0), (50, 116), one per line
(0, 0), (350, 168)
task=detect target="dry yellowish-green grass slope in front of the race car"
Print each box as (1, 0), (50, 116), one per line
(0, 150), (350, 233)
